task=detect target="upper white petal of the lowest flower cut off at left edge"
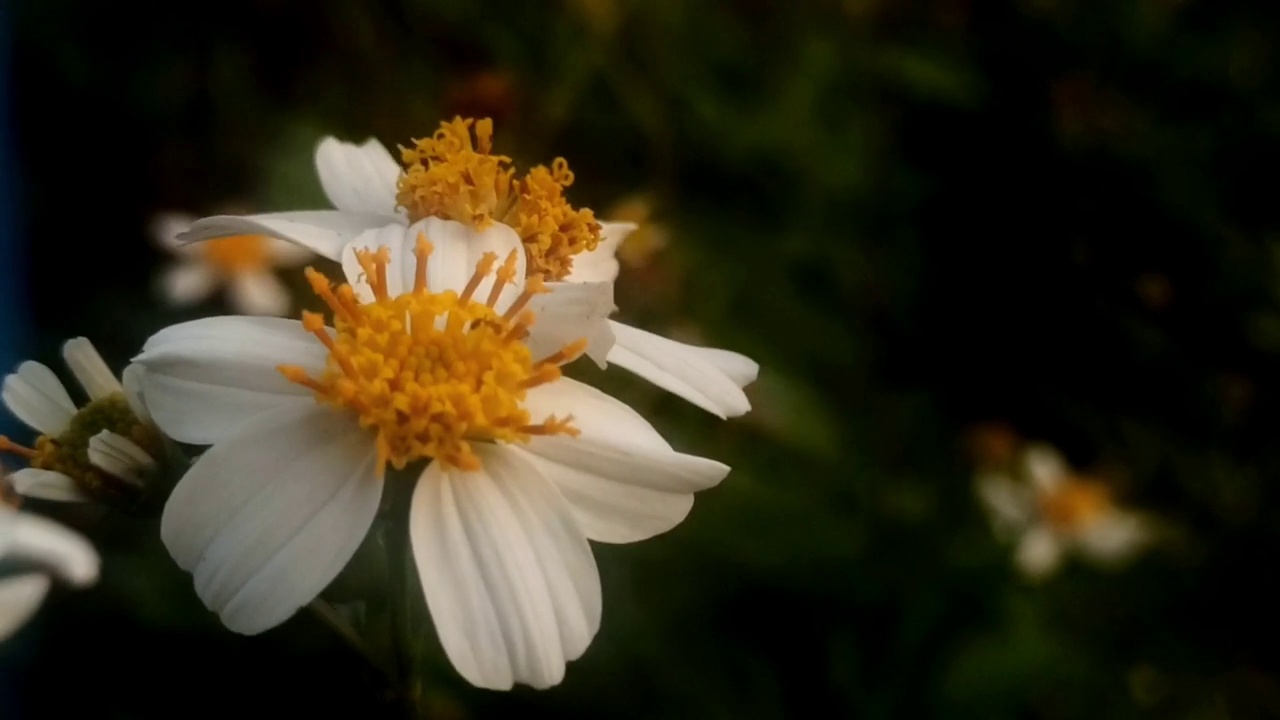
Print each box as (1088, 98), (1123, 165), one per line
(0, 507), (100, 587)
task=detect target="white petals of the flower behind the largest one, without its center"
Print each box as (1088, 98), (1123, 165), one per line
(166, 120), (759, 418)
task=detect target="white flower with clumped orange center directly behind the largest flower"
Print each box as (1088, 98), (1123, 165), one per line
(179, 118), (759, 418)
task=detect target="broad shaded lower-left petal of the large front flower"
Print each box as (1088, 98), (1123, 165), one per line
(160, 406), (383, 634)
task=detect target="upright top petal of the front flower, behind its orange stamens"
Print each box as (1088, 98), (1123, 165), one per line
(342, 218), (525, 304)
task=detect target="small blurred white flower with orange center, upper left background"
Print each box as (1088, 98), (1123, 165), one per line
(151, 213), (312, 315)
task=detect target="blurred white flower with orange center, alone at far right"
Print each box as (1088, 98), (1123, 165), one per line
(977, 443), (1153, 579)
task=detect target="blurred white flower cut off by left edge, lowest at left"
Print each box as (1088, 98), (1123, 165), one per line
(0, 491), (99, 641)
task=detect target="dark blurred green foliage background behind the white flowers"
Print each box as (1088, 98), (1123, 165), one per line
(0, 0), (1280, 719)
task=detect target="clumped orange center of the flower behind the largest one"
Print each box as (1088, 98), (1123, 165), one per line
(396, 118), (600, 281)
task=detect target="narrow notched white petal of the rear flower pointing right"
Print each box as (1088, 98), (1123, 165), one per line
(609, 320), (758, 418)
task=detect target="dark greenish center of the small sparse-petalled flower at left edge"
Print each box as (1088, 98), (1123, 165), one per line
(0, 393), (164, 502)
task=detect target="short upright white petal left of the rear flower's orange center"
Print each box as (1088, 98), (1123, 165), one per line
(316, 137), (401, 215)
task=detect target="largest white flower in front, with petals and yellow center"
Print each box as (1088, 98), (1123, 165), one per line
(136, 218), (728, 689)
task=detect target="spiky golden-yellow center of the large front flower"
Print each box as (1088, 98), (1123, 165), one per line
(279, 234), (586, 473)
